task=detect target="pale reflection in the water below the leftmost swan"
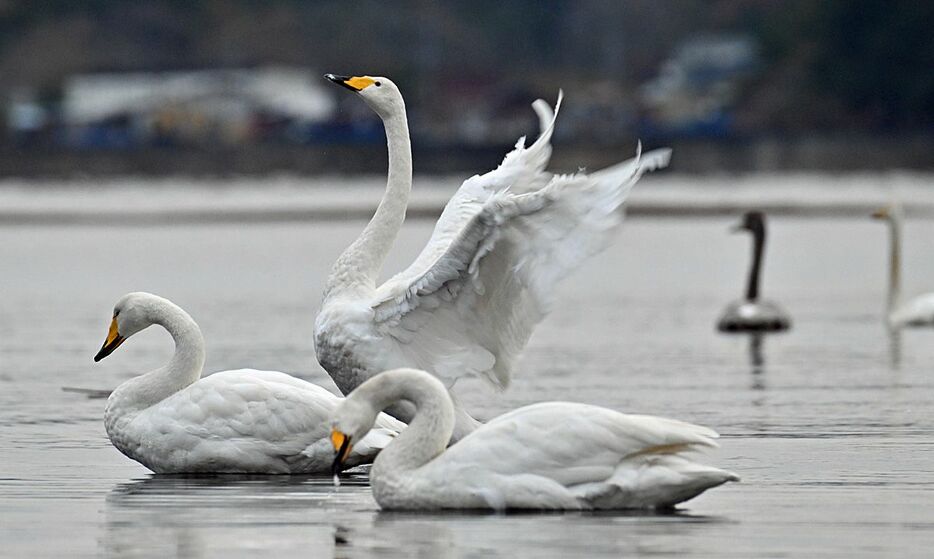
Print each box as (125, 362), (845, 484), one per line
(100, 474), (369, 558)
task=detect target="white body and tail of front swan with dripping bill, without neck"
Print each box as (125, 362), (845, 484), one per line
(402, 402), (737, 510)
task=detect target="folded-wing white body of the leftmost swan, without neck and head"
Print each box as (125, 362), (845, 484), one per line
(107, 369), (401, 474)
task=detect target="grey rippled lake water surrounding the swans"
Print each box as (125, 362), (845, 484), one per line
(0, 212), (934, 558)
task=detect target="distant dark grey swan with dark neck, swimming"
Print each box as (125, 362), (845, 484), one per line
(717, 212), (791, 332)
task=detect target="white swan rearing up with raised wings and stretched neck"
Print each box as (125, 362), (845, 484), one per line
(315, 74), (670, 440)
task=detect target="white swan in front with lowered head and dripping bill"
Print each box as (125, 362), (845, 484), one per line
(331, 369), (739, 510)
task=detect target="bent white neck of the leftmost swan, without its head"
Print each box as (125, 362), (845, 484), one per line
(105, 297), (204, 424)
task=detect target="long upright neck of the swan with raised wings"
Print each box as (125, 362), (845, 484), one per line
(326, 105), (412, 296)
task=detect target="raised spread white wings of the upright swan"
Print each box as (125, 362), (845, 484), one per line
(372, 95), (670, 387)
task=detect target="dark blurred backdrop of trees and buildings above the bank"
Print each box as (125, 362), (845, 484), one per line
(0, 0), (934, 176)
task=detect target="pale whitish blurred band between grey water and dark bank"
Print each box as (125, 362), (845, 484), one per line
(0, 171), (934, 226)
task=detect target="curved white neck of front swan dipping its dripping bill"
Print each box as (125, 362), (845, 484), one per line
(356, 369), (455, 477)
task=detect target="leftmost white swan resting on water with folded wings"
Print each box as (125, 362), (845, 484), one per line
(94, 293), (403, 474)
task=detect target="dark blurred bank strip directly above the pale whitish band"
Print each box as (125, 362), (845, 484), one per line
(0, 136), (934, 179)
